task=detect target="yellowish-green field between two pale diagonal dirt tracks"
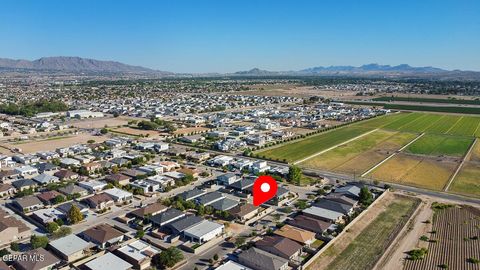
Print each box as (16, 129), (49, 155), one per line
(300, 130), (417, 174)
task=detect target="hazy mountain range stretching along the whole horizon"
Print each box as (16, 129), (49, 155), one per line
(0, 56), (480, 79)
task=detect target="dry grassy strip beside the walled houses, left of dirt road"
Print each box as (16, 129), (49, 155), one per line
(318, 196), (420, 270)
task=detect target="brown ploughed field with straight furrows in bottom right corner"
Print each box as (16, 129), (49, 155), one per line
(404, 206), (480, 270)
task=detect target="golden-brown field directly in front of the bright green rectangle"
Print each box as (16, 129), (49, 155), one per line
(366, 154), (458, 190)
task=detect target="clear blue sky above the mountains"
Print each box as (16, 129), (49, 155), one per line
(0, 0), (480, 72)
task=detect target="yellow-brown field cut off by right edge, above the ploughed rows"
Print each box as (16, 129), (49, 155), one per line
(448, 162), (480, 197)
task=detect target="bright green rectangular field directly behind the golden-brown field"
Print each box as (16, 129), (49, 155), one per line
(406, 134), (473, 157)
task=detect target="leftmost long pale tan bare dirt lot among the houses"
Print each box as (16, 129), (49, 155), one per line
(5, 133), (107, 153)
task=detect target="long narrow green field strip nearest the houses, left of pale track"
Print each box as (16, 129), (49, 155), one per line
(258, 125), (371, 162)
